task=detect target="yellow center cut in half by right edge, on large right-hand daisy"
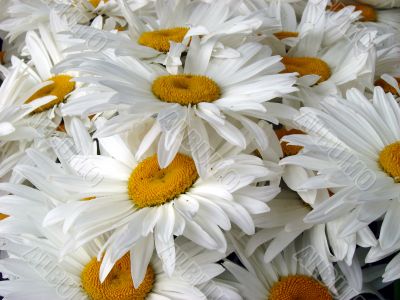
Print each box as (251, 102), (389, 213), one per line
(379, 142), (400, 182)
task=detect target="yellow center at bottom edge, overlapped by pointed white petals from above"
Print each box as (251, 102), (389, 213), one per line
(81, 254), (155, 300)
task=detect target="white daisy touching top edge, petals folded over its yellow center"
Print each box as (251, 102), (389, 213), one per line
(62, 0), (276, 74)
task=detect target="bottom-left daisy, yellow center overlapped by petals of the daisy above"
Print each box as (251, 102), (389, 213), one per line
(0, 221), (241, 300)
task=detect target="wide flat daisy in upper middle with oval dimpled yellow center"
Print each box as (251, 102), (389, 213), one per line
(57, 37), (296, 167)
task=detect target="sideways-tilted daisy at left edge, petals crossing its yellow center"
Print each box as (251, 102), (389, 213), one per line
(0, 24), (75, 182)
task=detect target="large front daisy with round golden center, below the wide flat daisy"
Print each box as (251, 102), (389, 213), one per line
(17, 117), (279, 283)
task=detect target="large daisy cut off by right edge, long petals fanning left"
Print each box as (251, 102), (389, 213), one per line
(282, 87), (400, 255)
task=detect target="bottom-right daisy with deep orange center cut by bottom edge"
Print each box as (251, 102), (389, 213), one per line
(224, 234), (382, 300)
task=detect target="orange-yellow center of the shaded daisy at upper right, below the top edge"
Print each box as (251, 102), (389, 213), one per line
(282, 56), (331, 83)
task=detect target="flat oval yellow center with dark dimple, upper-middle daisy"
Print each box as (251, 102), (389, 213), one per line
(151, 74), (221, 105)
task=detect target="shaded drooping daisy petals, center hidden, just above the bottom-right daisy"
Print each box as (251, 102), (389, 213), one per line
(250, 190), (377, 264)
